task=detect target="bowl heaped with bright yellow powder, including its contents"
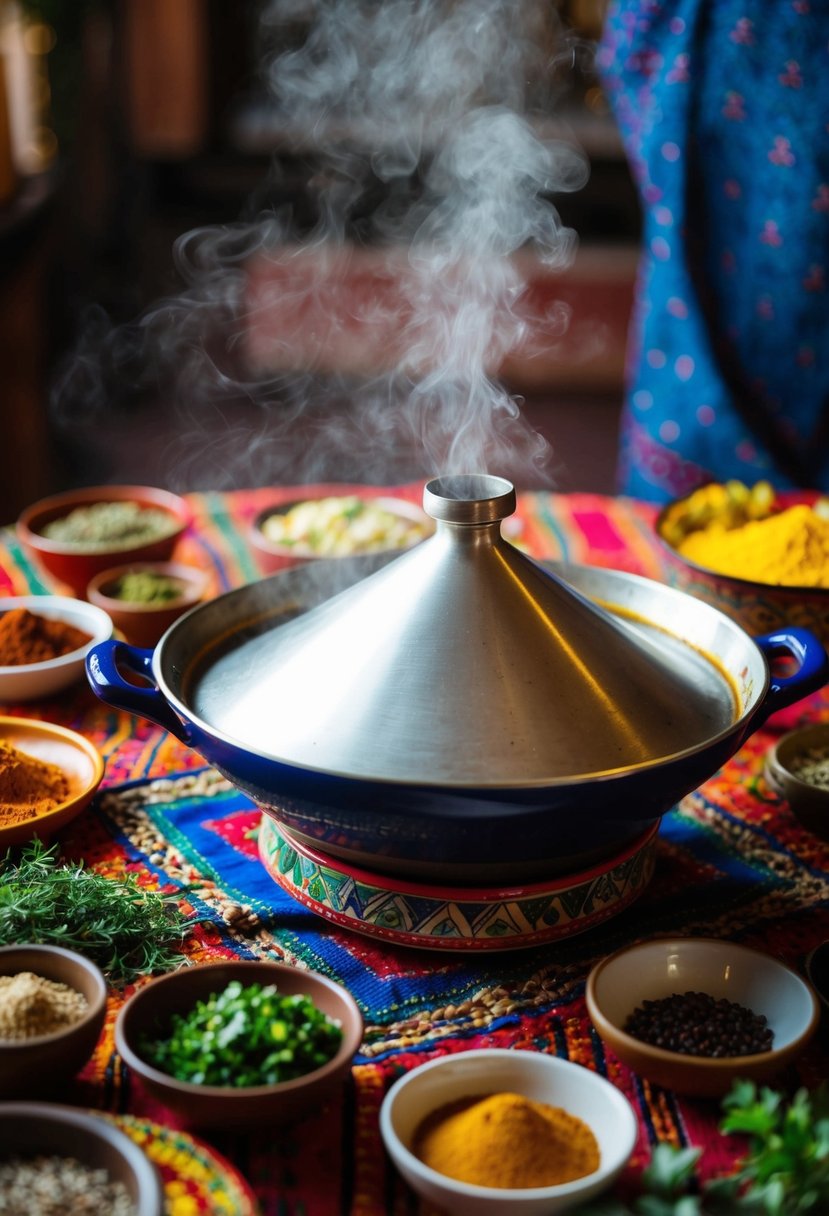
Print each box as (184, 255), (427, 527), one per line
(655, 480), (829, 644)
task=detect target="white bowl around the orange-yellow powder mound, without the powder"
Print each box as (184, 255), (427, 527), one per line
(380, 1047), (637, 1216)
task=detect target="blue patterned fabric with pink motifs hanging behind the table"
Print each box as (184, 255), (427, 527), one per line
(598, 0), (829, 502)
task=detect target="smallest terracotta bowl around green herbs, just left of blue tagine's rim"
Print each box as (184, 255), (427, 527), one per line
(86, 562), (208, 647)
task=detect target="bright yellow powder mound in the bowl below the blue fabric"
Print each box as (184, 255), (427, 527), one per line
(677, 503), (829, 587)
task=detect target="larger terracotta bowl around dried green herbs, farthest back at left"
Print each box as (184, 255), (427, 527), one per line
(17, 485), (191, 596)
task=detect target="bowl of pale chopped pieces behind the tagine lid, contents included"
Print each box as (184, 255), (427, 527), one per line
(250, 494), (434, 574)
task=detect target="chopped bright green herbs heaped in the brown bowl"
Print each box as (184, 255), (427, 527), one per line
(141, 980), (343, 1088)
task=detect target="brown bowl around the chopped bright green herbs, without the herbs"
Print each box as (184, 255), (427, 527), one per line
(115, 959), (362, 1127)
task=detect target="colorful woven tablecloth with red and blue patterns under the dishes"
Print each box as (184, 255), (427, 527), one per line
(0, 486), (829, 1216)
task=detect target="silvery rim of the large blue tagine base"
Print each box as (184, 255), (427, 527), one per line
(152, 558), (771, 799)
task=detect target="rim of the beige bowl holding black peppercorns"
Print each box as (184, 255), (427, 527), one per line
(585, 935), (820, 1073)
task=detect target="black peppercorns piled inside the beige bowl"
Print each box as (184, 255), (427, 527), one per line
(624, 992), (774, 1059)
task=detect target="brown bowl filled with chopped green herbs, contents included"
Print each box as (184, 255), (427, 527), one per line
(115, 959), (362, 1127)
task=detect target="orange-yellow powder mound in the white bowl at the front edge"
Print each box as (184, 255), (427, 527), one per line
(412, 1093), (599, 1189)
